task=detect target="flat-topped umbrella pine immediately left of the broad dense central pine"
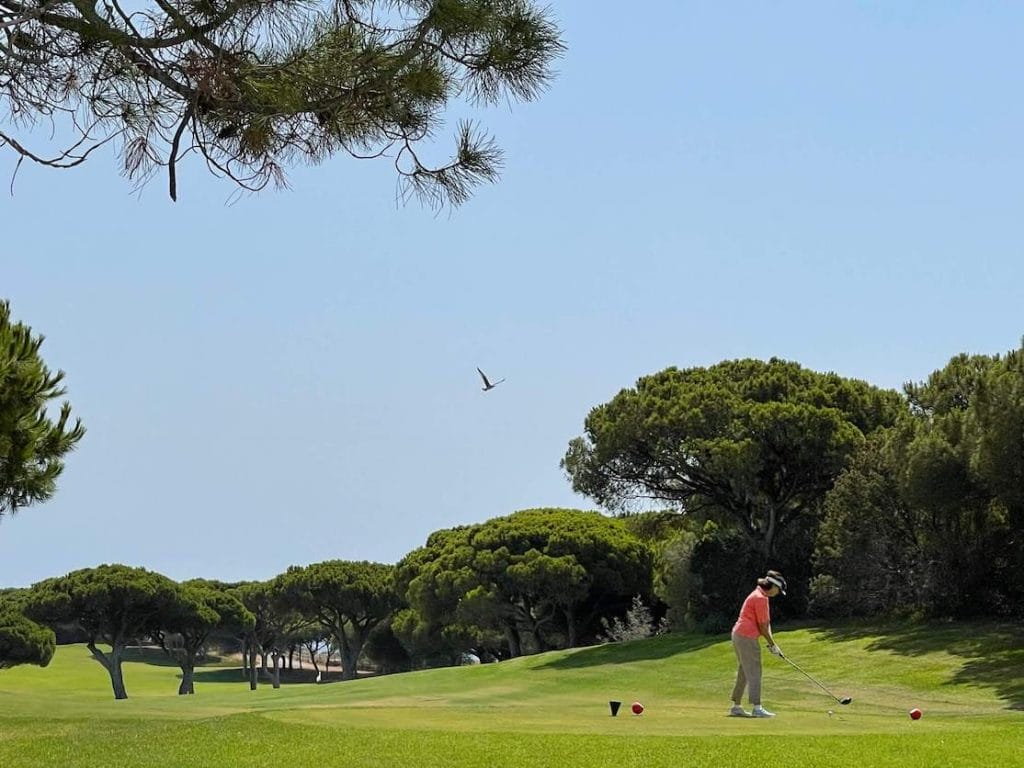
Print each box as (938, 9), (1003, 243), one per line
(278, 560), (398, 680)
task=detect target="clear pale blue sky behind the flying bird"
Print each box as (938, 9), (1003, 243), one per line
(0, 0), (1024, 586)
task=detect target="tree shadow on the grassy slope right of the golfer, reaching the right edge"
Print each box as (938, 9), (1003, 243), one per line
(812, 623), (1024, 710)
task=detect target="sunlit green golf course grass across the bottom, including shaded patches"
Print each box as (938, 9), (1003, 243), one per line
(0, 625), (1024, 768)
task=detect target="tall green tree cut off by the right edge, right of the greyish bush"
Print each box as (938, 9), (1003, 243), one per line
(892, 349), (1024, 616)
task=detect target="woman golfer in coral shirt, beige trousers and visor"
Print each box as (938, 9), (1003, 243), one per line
(729, 570), (785, 718)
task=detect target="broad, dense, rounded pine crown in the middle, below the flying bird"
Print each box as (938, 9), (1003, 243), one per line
(395, 509), (652, 657)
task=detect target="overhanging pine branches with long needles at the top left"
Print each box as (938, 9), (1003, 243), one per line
(0, 0), (563, 204)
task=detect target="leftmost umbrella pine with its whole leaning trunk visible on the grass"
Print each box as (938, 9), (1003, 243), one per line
(26, 565), (176, 698)
